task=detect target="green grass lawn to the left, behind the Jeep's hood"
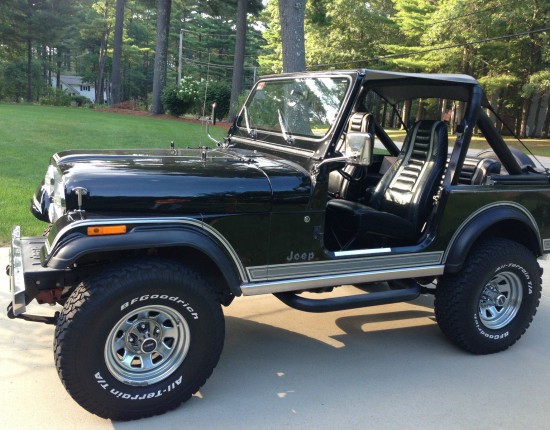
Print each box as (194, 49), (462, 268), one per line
(0, 104), (225, 246)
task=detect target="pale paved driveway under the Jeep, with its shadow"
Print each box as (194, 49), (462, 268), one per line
(0, 248), (550, 429)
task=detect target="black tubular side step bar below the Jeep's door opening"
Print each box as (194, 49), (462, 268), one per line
(274, 283), (422, 312)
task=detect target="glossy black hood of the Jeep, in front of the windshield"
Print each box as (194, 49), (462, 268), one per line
(53, 148), (311, 214)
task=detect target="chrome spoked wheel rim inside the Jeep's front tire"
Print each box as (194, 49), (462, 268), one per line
(105, 305), (190, 386)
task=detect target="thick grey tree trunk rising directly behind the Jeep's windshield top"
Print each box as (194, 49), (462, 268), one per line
(279, 0), (306, 72)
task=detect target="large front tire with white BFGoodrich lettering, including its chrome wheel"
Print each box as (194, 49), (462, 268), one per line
(54, 261), (225, 420)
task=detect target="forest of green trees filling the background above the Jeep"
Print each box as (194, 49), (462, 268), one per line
(0, 0), (550, 137)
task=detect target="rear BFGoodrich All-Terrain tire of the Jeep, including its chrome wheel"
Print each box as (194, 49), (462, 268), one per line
(435, 238), (541, 354)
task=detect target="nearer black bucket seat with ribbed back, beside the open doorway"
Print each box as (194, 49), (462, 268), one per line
(327, 120), (448, 249)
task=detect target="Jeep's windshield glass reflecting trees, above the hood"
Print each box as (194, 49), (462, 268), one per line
(237, 77), (349, 141)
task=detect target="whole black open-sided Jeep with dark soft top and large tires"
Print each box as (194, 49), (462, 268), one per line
(8, 70), (550, 419)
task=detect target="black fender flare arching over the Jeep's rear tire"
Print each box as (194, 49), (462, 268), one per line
(443, 202), (543, 273)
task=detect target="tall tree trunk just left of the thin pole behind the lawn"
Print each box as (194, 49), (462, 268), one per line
(151, 0), (172, 115)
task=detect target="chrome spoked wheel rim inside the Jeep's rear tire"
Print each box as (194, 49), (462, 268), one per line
(479, 272), (523, 330)
